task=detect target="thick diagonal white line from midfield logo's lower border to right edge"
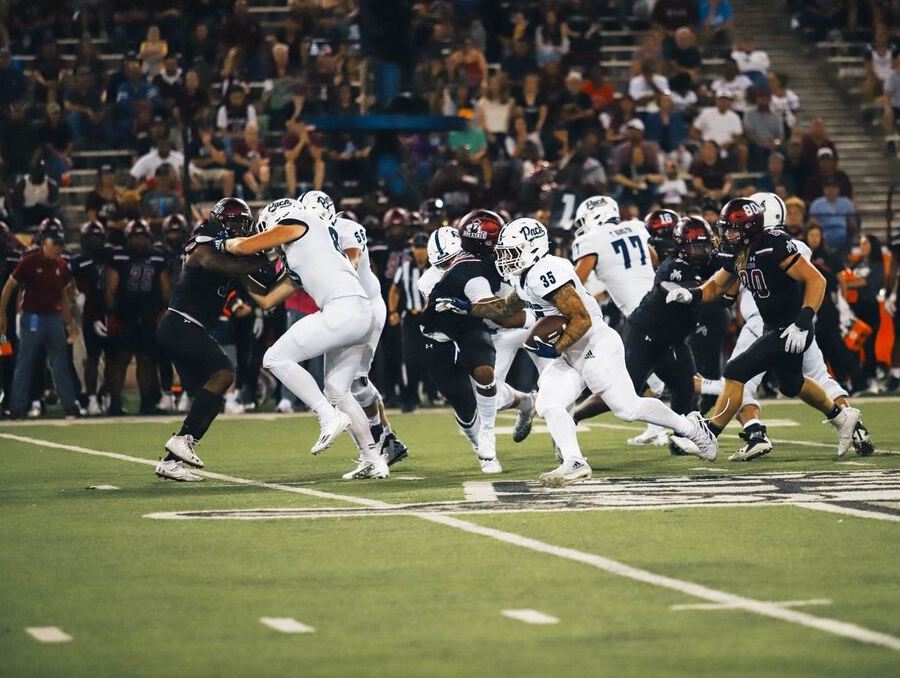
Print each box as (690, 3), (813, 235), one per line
(418, 513), (900, 651)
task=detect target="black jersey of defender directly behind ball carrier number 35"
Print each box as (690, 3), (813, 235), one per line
(419, 256), (500, 340)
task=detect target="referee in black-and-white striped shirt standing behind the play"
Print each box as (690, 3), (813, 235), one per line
(388, 233), (428, 412)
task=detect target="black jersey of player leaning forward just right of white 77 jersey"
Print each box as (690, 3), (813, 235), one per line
(628, 257), (704, 344)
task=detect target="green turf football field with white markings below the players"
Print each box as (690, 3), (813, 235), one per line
(0, 398), (900, 678)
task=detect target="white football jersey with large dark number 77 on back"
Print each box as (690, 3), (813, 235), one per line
(572, 219), (654, 317)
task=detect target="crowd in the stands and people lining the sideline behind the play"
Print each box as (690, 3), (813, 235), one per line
(0, 0), (900, 416)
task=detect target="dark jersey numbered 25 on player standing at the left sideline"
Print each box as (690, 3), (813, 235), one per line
(107, 248), (168, 317)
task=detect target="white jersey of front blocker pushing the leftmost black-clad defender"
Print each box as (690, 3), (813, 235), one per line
(277, 207), (368, 308)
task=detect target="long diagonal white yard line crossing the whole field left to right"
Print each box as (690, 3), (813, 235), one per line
(10, 433), (900, 651)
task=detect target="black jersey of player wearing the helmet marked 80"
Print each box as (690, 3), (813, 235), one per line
(718, 230), (803, 328)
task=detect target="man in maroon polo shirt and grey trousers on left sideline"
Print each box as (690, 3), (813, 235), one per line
(0, 228), (79, 418)
